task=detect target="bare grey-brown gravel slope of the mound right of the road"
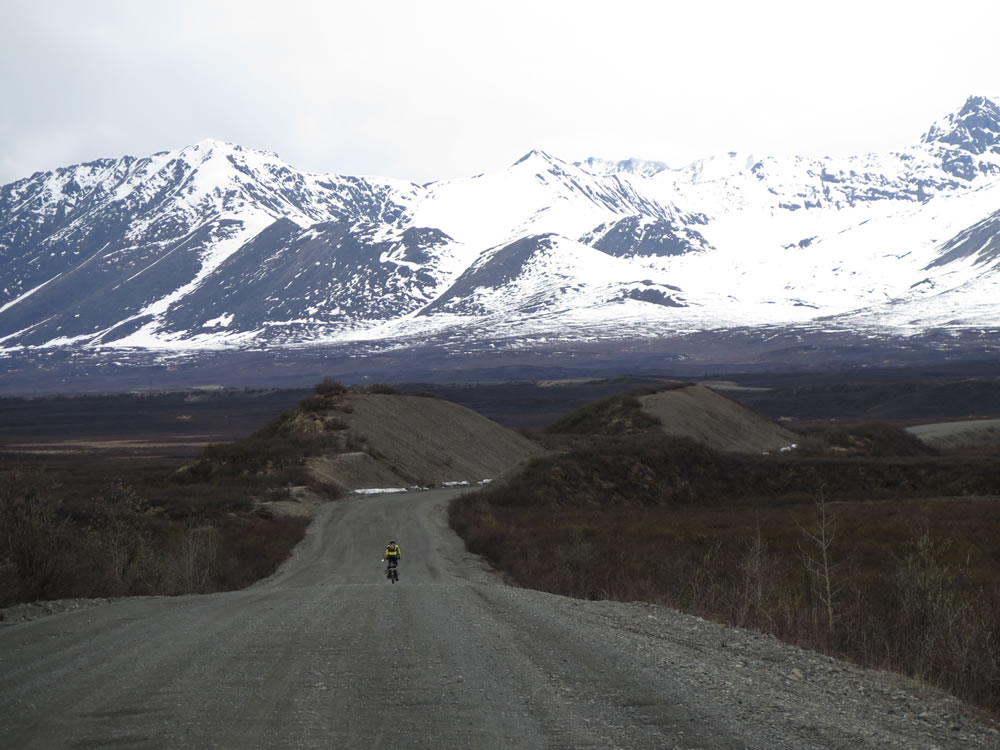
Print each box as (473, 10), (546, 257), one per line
(639, 385), (801, 453)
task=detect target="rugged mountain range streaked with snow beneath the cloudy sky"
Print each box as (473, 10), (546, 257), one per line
(0, 97), (1000, 368)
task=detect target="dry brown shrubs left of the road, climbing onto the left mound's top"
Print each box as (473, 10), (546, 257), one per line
(0, 381), (351, 606)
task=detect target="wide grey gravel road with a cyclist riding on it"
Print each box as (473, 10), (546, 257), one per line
(0, 490), (1000, 750)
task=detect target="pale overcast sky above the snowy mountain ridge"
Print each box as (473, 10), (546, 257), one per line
(0, 0), (1000, 184)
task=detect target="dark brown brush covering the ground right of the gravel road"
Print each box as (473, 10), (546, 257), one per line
(449, 436), (1000, 712)
